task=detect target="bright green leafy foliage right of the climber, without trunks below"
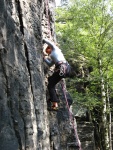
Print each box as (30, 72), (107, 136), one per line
(56, 0), (113, 112)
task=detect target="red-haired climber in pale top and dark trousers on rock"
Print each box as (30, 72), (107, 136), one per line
(43, 39), (71, 110)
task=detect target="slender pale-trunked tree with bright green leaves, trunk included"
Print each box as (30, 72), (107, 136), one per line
(56, 0), (113, 150)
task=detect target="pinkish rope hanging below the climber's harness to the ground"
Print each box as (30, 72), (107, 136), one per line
(61, 80), (82, 150)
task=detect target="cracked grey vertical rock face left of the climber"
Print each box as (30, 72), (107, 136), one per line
(0, 0), (50, 150)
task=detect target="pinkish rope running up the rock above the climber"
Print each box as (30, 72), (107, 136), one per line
(46, 0), (51, 39)
